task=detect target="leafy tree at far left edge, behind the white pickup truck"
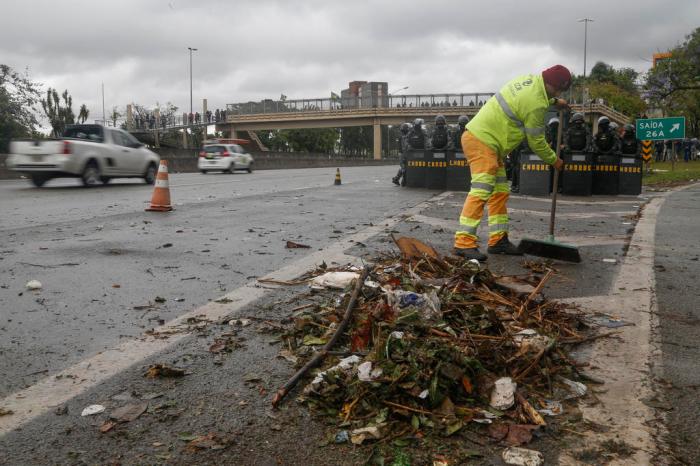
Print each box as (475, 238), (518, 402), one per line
(0, 64), (40, 152)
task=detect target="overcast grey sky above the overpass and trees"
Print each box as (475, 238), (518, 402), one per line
(0, 0), (700, 125)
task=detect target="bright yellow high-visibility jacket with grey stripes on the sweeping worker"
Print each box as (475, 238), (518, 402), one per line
(467, 74), (557, 165)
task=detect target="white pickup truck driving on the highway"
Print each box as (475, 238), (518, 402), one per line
(6, 125), (160, 187)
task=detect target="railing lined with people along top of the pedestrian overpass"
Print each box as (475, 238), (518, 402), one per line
(226, 92), (493, 116)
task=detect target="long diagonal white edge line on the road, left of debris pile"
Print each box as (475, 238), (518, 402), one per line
(0, 193), (449, 436)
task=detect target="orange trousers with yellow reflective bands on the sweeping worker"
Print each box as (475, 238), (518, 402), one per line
(455, 132), (510, 248)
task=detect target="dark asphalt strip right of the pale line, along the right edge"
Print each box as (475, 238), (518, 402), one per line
(654, 184), (700, 464)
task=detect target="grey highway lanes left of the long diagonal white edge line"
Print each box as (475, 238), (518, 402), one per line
(0, 167), (434, 396)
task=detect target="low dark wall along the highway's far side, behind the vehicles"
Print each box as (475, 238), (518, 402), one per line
(0, 151), (399, 179)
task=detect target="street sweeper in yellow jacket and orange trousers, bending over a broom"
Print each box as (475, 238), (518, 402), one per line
(454, 65), (571, 261)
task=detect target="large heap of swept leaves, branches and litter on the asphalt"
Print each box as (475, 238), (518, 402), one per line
(273, 238), (594, 460)
